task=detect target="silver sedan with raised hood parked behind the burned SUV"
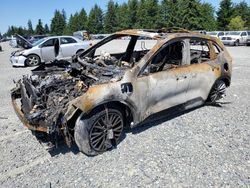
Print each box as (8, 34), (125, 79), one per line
(10, 35), (92, 66)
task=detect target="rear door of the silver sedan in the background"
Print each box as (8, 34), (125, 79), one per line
(60, 37), (77, 58)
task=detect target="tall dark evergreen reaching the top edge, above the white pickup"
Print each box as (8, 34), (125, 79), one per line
(217, 0), (233, 30)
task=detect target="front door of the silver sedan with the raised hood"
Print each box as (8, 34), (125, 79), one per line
(41, 38), (58, 62)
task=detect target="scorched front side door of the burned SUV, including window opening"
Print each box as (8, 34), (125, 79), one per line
(135, 40), (190, 119)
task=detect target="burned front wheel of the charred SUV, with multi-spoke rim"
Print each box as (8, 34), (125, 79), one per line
(74, 108), (124, 156)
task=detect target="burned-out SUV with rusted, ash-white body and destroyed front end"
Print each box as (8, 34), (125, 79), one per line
(11, 29), (232, 155)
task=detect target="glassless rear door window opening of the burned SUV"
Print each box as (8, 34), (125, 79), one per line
(190, 39), (210, 64)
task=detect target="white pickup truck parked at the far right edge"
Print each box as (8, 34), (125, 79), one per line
(221, 31), (250, 46)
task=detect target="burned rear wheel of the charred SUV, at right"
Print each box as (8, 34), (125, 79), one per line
(207, 80), (227, 103)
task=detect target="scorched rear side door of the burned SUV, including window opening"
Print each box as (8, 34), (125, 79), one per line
(186, 38), (220, 104)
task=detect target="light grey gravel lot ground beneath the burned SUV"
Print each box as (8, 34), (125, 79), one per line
(0, 43), (250, 188)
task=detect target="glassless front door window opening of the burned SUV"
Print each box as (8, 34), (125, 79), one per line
(143, 41), (184, 75)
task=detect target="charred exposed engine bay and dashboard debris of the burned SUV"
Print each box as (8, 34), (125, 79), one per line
(12, 53), (135, 146)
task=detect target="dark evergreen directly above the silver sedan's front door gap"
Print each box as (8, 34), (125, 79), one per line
(50, 10), (66, 35)
